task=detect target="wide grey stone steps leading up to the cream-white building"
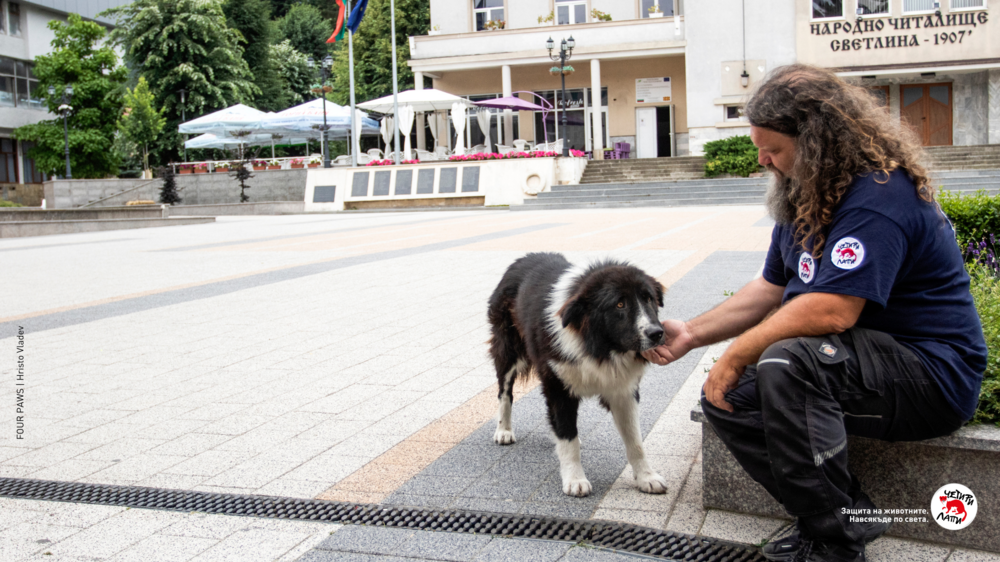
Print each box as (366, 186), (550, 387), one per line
(511, 145), (1000, 211)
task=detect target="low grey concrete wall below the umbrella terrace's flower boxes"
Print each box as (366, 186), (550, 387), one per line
(45, 169), (306, 209)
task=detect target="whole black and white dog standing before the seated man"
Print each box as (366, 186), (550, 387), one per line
(489, 253), (667, 497)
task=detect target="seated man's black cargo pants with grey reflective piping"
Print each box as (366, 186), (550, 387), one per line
(701, 328), (965, 552)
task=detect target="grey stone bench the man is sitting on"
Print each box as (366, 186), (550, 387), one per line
(691, 406), (1000, 552)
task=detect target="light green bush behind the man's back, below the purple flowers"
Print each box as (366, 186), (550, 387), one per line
(969, 264), (1000, 426)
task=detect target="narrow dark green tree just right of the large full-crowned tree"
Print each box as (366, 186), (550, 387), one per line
(222, 0), (289, 111)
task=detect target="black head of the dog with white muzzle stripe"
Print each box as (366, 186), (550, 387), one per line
(559, 262), (664, 358)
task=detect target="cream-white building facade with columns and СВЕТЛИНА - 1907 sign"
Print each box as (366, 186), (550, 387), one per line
(409, 0), (1000, 158)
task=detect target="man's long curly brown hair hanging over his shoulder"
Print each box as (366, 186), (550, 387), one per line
(745, 64), (934, 258)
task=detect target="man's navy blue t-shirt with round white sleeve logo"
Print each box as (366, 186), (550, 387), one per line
(764, 170), (986, 419)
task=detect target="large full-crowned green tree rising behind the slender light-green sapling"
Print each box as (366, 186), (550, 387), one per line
(100, 0), (260, 163)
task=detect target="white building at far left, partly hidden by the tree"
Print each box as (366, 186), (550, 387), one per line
(0, 0), (129, 188)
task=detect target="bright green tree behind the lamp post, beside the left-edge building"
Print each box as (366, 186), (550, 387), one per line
(14, 14), (127, 178)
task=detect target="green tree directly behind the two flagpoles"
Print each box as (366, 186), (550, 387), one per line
(333, 0), (431, 105)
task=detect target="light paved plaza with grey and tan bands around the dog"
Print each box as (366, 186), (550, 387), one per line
(0, 206), (1000, 562)
